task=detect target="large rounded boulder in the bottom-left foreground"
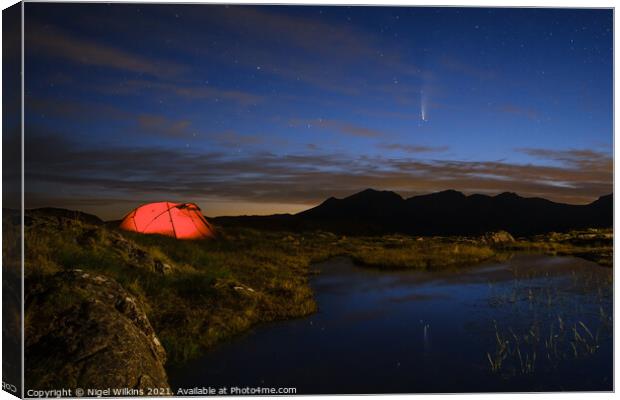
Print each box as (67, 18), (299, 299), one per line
(25, 270), (169, 390)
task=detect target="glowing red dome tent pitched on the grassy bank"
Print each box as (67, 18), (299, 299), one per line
(120, 201), (215, 239)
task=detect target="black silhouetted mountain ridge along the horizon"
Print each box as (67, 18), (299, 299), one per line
(213, 189), (613, 235)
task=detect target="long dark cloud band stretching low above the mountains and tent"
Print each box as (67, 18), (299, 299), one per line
(26, 132), (613, 217)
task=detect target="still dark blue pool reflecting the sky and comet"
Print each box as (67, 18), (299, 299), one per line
(169, 255), (613, 394)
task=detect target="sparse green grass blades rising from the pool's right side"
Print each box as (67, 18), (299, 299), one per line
(486, 255), (613, 377)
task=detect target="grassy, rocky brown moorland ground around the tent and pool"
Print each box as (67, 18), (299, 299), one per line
(3, 203), (613, 394)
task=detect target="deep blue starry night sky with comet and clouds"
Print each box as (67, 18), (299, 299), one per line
(25, 3), (613, 218)
